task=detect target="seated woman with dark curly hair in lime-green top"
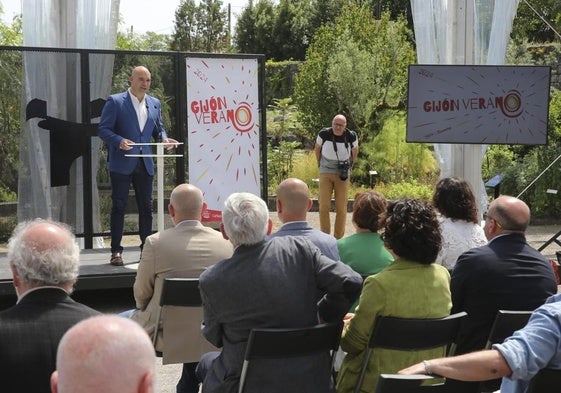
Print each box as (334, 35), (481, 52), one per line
(337, 199), (452, 393)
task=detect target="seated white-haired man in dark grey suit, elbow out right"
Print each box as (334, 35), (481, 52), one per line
(197, 193), (362, 393)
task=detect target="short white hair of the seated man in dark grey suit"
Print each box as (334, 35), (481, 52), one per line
(222, 192), (269, 246)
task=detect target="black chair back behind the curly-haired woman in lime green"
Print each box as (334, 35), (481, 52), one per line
(354, 311), (467, 393)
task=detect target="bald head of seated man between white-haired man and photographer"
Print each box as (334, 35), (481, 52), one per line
(277, 178), (312, 223)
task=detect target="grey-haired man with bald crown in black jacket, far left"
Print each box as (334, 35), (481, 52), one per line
(0, 220), (99, 393)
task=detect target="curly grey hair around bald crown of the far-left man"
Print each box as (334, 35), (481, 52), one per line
(8, 219), (80, 286)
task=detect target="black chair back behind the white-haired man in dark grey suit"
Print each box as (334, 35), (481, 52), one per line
(239, 321), (343, 393)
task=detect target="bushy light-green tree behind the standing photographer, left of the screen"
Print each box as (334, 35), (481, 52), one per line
(294, 4), (415, 134)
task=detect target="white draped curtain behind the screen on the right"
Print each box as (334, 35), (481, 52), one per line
(411, 0), (519, 213)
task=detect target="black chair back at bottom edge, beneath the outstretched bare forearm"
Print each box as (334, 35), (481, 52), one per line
(375, 374), (474, 393)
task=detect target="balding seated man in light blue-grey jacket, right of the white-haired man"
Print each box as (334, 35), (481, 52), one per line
(270, 178), (340, 261)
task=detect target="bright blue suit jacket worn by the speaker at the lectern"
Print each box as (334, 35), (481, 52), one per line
(98, 90), (167, 176)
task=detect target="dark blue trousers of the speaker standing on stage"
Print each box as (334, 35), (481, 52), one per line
(110, 158), (154, 252)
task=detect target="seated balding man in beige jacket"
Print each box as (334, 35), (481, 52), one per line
(131, 184), (233, 393)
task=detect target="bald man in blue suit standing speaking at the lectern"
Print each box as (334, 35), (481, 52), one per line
(98, 66), (177, 266)
